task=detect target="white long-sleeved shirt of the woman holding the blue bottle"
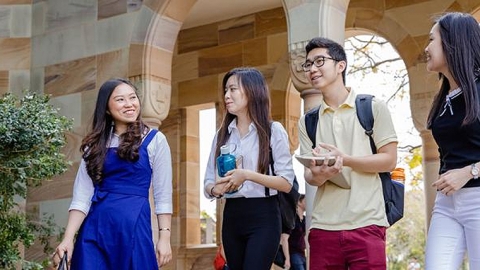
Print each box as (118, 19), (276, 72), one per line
(203, 119), (295, 198)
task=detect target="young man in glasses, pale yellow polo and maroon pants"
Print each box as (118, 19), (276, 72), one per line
(299, 38), (397, 270)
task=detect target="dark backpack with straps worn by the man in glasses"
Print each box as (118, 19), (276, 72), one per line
(305, 94), (405, 226)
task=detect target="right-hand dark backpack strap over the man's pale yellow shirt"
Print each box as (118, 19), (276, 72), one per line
(355, 94), (377, 154)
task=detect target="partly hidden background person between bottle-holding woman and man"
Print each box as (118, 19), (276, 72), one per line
(288, 194), (307, 270)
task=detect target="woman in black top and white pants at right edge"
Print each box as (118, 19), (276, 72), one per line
(425, 12), (480, 270)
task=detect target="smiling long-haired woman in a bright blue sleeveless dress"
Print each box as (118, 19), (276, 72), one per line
(54, 79), (172, 270)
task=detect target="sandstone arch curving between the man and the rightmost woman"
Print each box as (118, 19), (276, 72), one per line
(346, 4), (438, 229)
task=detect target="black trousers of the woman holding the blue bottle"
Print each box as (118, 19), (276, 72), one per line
(222, 196), (282, 270)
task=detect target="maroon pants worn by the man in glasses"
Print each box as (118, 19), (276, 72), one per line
(308, 225), (387, 270)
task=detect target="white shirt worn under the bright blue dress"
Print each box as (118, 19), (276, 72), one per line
(69, 131), (173, 215)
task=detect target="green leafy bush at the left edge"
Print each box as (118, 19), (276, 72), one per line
(0, 93), (72, 269)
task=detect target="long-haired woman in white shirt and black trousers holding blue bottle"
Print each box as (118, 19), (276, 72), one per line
(204, 68), (294, 270)
